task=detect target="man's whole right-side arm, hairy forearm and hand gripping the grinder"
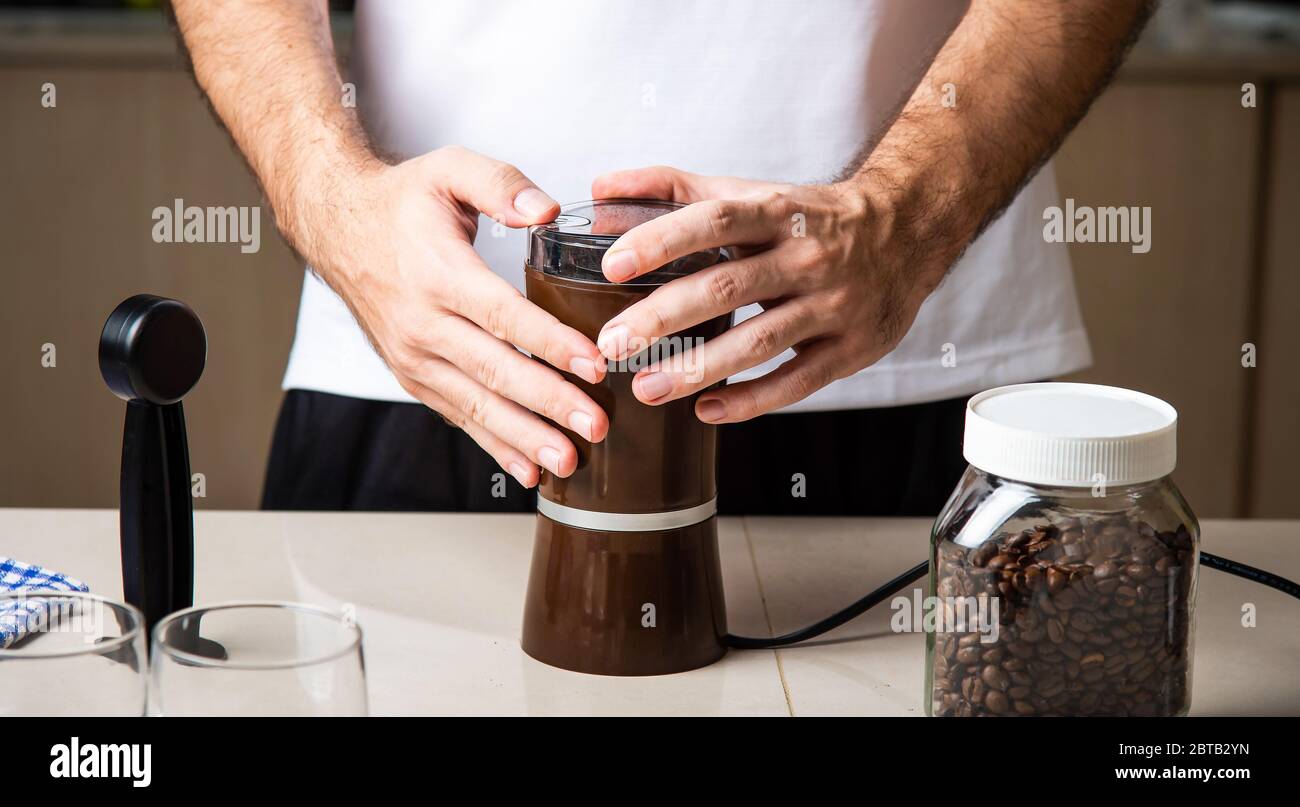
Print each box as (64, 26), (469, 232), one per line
(592, 0), (1153, 422)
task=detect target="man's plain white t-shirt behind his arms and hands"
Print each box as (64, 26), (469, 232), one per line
(283, 0), (1091, 411)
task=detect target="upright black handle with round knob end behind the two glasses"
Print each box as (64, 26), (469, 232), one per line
(99, 294), (208, 632)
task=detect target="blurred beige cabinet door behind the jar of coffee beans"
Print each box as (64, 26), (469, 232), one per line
(1056, 82), (1258, 517)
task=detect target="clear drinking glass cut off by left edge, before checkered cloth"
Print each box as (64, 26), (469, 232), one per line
(0, 589), (147, 717)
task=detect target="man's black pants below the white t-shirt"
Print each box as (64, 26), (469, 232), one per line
(261, 390), (966, 516)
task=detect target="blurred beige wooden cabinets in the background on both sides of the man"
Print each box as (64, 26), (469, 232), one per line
(0, 39), (1300, 517)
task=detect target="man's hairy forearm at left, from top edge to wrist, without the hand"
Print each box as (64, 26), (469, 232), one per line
(172, 0), (378, 260)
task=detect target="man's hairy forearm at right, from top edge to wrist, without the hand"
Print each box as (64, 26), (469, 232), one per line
(850, 0), (1151, 285)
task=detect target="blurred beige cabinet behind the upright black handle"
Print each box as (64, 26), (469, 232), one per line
(0, 67), (302, 508)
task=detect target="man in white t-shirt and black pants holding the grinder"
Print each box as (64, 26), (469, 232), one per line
(173, 0), (1149, 515)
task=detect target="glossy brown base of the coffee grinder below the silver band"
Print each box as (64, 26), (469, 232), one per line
(521, 515), (727, 676)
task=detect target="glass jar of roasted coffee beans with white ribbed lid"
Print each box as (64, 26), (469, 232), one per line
(926, 383), (1200, 716)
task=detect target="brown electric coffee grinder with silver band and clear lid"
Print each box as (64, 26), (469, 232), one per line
(523, 200), (731, 676)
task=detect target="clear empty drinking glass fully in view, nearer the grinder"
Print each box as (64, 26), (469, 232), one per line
(150, 602), (368, 716)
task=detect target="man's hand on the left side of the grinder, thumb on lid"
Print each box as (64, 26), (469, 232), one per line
(299, 147), (608, 487)
